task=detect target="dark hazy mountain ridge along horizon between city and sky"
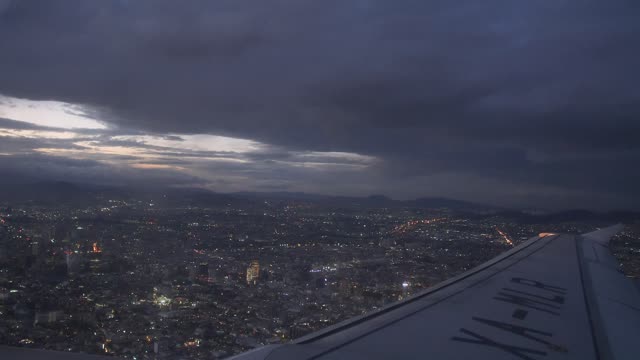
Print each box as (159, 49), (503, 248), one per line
(0, 181), (640, 223)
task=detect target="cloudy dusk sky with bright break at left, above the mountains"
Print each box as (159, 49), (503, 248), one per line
(0, 0), (640, 210)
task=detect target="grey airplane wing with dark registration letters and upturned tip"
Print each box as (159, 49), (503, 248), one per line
(232, 225), (640, 360)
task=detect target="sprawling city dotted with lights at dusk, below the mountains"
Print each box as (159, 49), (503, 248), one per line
(0, 194), (640, 359)
